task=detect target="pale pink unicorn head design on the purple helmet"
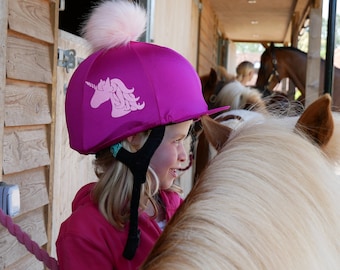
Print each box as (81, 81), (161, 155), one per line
(85, 78), (145, 118)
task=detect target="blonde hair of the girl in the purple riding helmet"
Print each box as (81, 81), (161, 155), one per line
(92, 132), (182, 229)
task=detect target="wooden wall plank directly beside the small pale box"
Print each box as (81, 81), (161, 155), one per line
(3, 167), (49, 215)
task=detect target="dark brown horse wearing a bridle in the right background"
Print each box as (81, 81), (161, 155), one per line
(256, 44), (340, 111)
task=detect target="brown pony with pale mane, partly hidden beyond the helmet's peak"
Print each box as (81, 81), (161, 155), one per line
(194, 67), (304, 182)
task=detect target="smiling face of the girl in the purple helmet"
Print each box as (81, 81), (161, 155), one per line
(150, 120), (192, 189)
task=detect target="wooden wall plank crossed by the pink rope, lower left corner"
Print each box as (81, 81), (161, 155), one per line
(0, 208), (47, 269)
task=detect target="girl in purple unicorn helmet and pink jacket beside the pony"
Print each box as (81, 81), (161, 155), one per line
(56, 0), (229, 270)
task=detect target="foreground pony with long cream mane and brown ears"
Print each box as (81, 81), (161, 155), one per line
(141, 94), (340, 270)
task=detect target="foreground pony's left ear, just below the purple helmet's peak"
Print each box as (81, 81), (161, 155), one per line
(201, 115), (232, 151)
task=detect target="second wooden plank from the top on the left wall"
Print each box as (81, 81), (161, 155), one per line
(6, 36), (52, 84)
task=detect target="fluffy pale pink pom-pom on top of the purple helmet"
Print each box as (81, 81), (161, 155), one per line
(82, 0), (146, 51)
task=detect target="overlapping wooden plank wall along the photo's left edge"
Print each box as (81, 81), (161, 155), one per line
(0, 0), (57, 269)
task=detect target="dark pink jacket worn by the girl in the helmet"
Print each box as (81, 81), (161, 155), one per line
(56, 183), (182, 270)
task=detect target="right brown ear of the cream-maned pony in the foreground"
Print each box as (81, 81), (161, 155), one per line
(296, 94), (334, 147)
